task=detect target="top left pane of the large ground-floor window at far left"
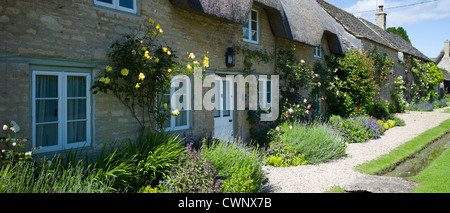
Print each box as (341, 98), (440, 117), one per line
(36, 75), (58, 98)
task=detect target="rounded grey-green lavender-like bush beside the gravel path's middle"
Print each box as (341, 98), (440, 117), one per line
(272, 121), (346, 164)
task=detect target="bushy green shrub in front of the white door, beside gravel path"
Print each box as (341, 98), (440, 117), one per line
(203, 141), (264, 193)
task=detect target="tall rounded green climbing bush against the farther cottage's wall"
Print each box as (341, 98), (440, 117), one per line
(327, 50), (379, 116)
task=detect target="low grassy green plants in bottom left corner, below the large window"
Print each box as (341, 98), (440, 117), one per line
(0, 161), (114, 193)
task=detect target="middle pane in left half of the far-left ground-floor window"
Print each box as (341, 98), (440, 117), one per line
(36, 100), (58, 123)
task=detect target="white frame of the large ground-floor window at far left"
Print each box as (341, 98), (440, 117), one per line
(32, 71), (92, 153)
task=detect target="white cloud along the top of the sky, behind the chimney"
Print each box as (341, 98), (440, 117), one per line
(345, 0), (450, 27)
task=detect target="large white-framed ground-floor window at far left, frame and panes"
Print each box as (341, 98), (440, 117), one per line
(32, 71), (91, 153)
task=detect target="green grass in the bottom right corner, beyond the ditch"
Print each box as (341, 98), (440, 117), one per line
(408, 146), (450, 193)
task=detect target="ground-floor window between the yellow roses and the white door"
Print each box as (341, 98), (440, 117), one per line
(162, 75), (191, 131)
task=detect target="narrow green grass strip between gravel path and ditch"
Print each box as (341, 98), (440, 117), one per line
(355, 119), (450, 175)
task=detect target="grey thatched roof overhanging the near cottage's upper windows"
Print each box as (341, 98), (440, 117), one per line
(170, 0), (341, 52)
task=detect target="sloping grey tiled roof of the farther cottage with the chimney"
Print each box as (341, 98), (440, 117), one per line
(316, 0), (430, 61)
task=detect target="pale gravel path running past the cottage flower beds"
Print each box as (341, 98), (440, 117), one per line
(263, 107), (450, 193)
